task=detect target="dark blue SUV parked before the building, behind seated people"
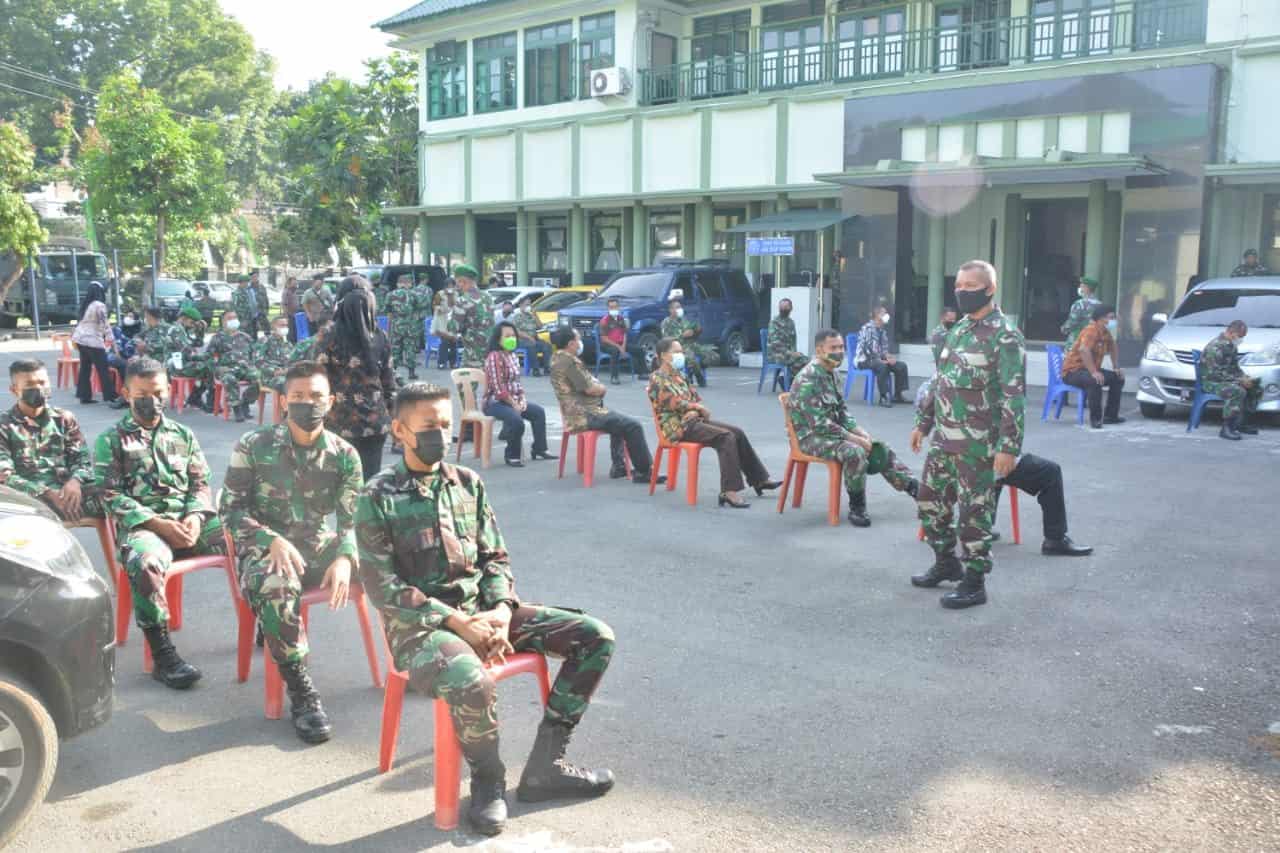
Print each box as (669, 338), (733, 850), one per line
(559, 261), (760, 369)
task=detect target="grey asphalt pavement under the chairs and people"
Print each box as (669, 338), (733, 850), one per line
(0, 342), (1280, 853)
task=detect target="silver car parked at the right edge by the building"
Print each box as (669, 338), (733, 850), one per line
(1138, 275), (1280, 418)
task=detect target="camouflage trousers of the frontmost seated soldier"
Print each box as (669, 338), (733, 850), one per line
(387, 605), (613, 757)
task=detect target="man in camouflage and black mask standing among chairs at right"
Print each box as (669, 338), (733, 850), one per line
(911, 260), (1027, 610)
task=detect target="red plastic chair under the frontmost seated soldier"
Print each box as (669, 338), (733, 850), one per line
(378, 634), (552, 831)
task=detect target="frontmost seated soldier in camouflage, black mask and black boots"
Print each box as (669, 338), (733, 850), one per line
(356, 383), (614, 835)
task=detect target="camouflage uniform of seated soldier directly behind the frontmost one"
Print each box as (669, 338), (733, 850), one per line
(218, 424), (364, 665)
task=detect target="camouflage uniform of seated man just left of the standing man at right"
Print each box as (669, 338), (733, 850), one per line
(787, 360), (915, 494)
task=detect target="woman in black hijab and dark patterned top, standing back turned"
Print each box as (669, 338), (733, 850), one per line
(315, 287), (396, 480)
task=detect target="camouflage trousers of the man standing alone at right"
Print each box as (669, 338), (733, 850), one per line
(916, 447), (996, 573)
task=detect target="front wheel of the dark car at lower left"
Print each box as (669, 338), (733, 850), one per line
(0, 675), (58, 849)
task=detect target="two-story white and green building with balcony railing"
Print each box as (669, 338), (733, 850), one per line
(378, 0), (1280, 356)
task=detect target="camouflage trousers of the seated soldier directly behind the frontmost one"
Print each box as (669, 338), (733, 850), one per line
(237, 534), (339, 665)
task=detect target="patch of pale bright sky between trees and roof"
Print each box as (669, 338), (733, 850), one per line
(221, 0), (415, 90)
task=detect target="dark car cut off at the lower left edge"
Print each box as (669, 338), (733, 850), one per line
(0, 485), (115, 848)
